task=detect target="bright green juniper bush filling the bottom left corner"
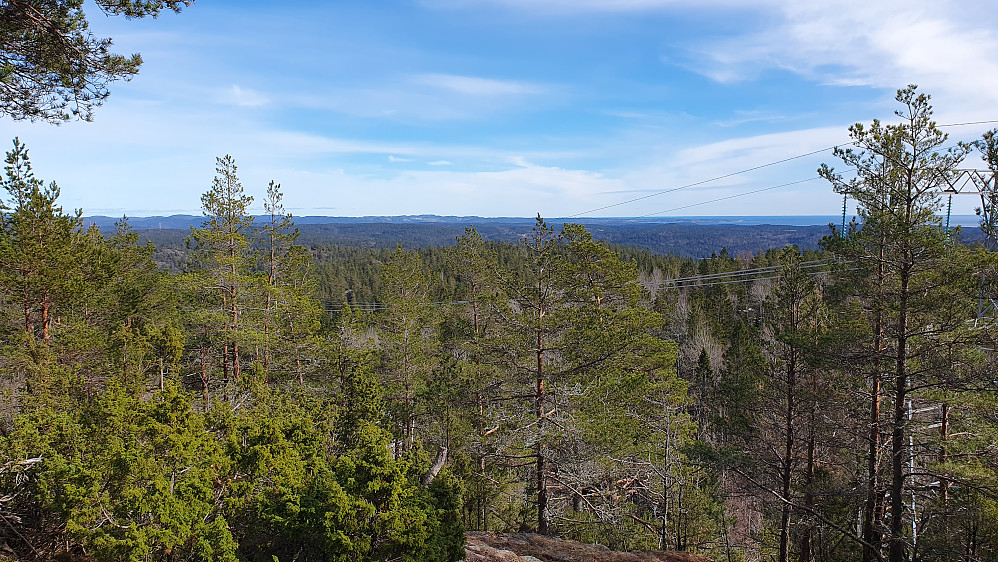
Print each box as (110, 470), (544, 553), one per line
(3, 386), (236, 561)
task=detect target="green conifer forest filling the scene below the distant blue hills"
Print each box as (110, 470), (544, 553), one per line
(0, 87), (998, 562)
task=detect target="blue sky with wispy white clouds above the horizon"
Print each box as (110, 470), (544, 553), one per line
(0, 0), (998, 218)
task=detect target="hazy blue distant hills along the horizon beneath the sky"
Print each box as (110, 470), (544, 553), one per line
(84, 215), (981, 258)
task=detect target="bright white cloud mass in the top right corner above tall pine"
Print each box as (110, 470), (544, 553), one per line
(693, 0), (998, 117)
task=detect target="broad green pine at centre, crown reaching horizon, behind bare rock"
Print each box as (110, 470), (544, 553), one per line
(480, 217), (689, 545)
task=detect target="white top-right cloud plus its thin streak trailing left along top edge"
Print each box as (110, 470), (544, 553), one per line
(434, 0), (998, 119)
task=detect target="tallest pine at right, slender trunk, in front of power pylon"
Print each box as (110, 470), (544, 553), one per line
(820, 86), (984, 562)
